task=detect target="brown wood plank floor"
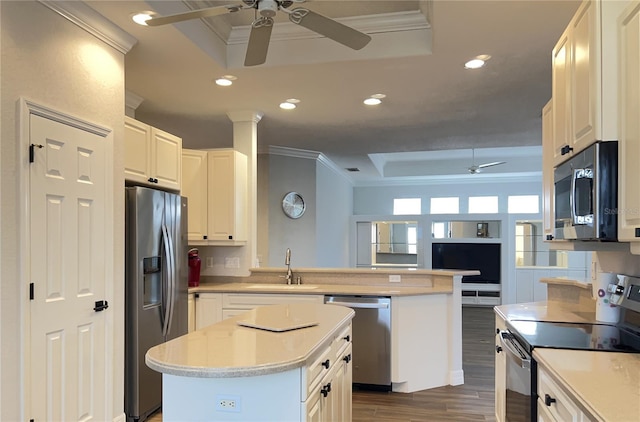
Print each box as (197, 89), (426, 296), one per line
(148, 307), (495, 422)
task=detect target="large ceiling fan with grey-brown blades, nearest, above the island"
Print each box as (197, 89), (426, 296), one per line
(140, 0), (371, 66)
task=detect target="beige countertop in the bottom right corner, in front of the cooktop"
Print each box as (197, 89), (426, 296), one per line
(533, 348), (640, 422)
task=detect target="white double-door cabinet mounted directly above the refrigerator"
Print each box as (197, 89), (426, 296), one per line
(124, 116), (182, 191)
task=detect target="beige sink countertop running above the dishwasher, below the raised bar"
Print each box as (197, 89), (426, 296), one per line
(189, 282), (453, 296)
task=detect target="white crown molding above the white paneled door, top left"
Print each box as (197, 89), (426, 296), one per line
(38, 0), (138, 54)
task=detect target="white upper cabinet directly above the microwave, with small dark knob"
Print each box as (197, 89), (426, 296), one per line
(552, 0), (624, 165)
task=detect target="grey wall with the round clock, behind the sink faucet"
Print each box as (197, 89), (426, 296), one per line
(258, 153), (353, 268)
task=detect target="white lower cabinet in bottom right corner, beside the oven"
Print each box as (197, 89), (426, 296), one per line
(538, 366), (595, 422)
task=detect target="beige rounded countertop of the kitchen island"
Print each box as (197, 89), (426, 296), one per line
(145, 304), (354, 378)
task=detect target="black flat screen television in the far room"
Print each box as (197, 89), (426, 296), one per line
(431, 242), (501, 284)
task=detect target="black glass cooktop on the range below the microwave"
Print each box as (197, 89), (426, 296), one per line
(507, 320), (640, 353)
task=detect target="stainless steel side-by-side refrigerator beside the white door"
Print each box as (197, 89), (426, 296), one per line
(125, 187), (188, 421)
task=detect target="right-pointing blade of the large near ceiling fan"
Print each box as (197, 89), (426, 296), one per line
(289, 7), (371, 50)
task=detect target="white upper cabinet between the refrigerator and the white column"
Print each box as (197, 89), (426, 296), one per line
(182, 148), (248, 246)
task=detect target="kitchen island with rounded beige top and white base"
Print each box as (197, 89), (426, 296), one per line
(146, 304), (354, 421)
